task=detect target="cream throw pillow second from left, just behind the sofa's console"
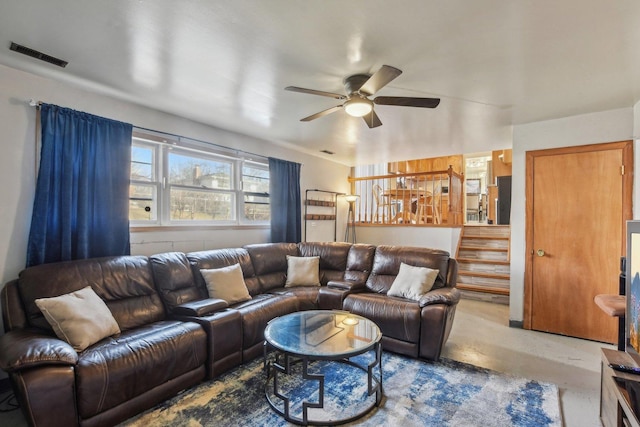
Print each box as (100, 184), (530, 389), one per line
(200, 264), (251, 305)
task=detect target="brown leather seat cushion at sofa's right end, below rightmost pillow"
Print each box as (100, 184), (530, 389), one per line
(343, 293), (421, 343)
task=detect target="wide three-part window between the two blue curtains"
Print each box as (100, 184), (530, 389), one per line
(129, 133), (270, 226)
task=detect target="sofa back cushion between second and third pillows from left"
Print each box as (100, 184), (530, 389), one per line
(244, 243), (300, 295)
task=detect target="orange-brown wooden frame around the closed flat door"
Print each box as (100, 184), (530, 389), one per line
(522, 140), (633, 329)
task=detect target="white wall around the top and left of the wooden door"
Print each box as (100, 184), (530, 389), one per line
(509, 108), (640, 322)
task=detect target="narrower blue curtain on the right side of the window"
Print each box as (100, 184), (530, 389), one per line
(269, 157), (302, 243)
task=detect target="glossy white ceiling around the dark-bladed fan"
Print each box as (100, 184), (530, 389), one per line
(0, 0), (640, 164)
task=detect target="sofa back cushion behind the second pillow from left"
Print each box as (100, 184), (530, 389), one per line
(187, 248), (261, 298)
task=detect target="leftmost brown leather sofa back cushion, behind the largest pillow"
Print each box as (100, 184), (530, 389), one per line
(19, 256), (165, 331)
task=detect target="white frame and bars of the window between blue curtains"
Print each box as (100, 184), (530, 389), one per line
(130, 130), (269, 228)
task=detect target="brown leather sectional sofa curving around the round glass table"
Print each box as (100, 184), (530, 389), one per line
(0, 243), (459, 426)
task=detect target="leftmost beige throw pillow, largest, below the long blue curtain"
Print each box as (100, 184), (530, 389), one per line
(35, 286), (120, 352)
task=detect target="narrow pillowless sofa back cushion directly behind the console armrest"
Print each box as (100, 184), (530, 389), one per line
(149, 252), (208, 312)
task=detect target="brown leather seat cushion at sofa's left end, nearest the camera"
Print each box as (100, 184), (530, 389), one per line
(76, 321), (207, 419)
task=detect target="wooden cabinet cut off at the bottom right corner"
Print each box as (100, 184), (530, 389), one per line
(600, 349), (640, 427)
